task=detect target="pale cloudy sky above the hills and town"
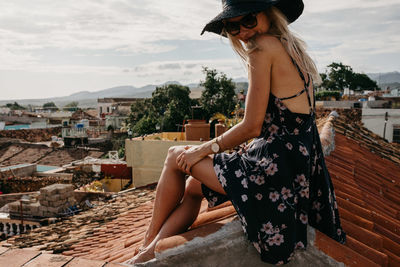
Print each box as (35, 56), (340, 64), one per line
(0, 0), (400, 100)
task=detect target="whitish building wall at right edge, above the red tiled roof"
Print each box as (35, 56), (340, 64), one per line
(361, 109), (400, 142)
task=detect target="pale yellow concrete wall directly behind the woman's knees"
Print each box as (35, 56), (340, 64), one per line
(125, 139), (201, 187)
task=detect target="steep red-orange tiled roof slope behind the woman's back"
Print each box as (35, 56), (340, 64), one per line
(317, 122), (400, 266)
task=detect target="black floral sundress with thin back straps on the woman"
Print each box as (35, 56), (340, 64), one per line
(202, 62), (346, 264)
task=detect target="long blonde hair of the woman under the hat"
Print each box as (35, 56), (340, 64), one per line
(225, 7), (321, 84)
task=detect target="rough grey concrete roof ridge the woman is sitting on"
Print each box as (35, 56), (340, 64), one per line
(140, 220), (345, 267)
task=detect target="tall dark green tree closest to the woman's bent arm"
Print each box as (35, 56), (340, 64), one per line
(200, 67), (236, 120)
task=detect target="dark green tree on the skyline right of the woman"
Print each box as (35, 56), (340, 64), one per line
(318, 62), (378, 92)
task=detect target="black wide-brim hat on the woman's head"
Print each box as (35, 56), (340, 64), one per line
(201, 0), (304, 36)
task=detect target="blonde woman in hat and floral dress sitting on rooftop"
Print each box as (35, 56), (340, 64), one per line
(131, 0), (345, 264)
